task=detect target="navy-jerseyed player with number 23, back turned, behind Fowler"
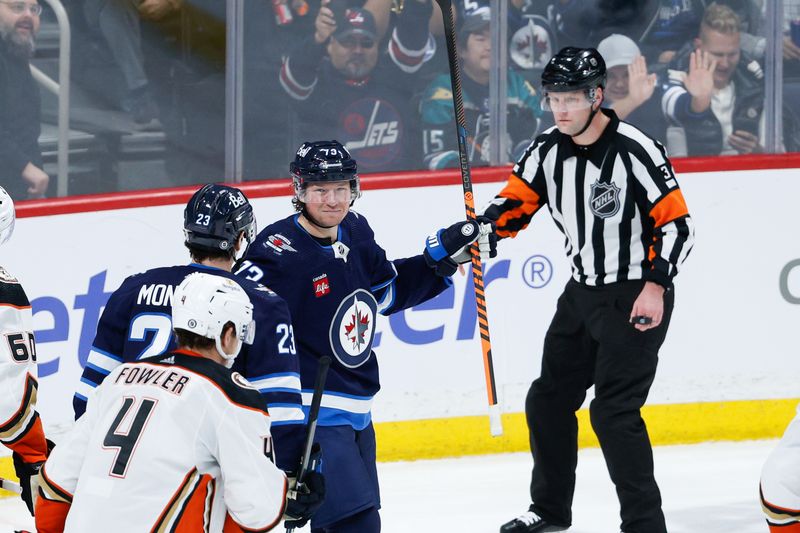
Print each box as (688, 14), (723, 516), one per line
(73, 184), (305, 470)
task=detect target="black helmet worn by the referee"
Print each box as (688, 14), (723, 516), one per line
(542, 46), (606, 93)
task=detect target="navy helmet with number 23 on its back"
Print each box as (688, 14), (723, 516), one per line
(183, 183), (256, 255)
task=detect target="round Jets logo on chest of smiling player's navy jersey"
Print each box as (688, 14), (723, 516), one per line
(330, 289), (378, 368)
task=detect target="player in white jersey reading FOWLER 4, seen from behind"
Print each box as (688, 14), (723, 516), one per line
(36, 273), (324, 533)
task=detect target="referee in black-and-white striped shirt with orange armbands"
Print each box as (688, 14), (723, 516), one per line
(484, 47), (694, 533)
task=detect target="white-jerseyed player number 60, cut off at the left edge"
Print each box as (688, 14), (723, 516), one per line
(0, 187), (47, 514)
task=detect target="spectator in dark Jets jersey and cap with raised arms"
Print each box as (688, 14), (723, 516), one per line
(280, 0), (433, 172)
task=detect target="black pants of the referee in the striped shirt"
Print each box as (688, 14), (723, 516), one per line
(525, 280), (674, 533)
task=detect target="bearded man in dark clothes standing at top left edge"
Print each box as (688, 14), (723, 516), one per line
(0, 0), (50, 199)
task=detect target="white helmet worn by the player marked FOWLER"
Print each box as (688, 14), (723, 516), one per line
(172, 272), (256, 368)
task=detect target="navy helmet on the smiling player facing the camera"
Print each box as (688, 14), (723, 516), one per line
(289, 140), (361, 205)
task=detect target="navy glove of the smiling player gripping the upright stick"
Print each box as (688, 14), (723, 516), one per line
(423, 217), (497, 276)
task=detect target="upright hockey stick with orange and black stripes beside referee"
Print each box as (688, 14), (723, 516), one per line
(436, 0), (503, 437)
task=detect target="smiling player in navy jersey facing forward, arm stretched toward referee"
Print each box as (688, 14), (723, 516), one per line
(238, 141), (492, 533)
